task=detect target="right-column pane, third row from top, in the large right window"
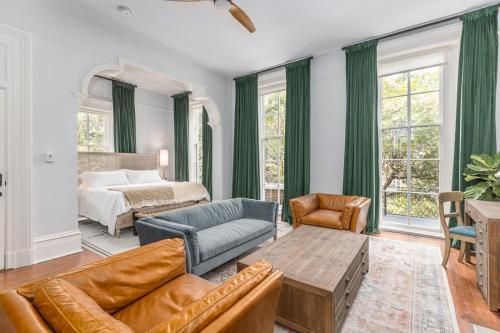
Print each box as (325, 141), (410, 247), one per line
(411, 126), (439, 159)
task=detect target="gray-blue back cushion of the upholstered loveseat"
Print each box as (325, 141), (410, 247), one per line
(156, 199), (243, 231)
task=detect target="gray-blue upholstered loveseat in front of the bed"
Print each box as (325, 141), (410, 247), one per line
(135, 198), (278, 275)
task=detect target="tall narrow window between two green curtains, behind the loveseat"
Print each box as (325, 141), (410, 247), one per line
(260, 89), (286, 205)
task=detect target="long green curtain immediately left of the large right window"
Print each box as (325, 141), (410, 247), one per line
(343, 41), (380, 234)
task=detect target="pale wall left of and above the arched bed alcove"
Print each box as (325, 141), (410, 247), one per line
(0, 0), (227, 260)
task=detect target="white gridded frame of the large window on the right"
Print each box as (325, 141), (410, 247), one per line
(377, 63), (447, 233)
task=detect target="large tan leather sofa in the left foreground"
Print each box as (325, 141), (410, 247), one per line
(0, 239), (283, 333)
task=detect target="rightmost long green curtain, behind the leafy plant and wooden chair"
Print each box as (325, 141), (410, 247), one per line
(450, 6), (498, 235)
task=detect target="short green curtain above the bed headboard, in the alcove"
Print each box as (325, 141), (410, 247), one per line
(112, 81), (136, 153)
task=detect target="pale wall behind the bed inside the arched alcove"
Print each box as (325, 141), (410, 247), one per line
(89, 78), (174, 179)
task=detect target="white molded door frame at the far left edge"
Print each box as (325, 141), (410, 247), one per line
(0, 23), (33, 268)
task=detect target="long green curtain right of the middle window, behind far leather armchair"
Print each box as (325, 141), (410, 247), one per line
(281, 59), (311, 223)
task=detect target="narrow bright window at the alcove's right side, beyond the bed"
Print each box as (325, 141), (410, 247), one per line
(189, 105), (203, 183)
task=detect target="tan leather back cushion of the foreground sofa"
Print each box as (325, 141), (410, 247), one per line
(18, 239), (186, 313)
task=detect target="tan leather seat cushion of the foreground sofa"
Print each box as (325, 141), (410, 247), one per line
(113, 274), (217, 332)
